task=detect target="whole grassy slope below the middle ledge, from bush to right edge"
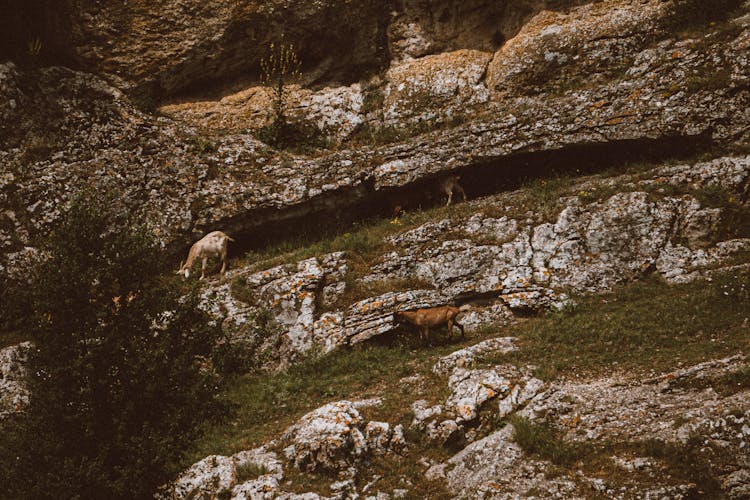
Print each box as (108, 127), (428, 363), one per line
(186, 271), (750, 497)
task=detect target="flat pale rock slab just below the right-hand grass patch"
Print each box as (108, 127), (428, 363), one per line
(521, 356), (750, 446)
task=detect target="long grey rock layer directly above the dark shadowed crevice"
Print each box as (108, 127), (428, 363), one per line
(0, 0), (750, 274)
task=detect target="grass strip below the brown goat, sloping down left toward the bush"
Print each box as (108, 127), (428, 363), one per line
(185, 336), (468, 465)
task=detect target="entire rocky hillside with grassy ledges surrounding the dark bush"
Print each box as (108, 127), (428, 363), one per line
(0, 0), (750, 499)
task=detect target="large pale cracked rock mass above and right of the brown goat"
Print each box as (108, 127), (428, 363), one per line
(366, 157), (750, 309)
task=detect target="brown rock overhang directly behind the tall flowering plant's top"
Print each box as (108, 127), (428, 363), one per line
(58, 0), (388, 97)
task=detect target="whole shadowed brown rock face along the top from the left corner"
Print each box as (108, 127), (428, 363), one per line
(0, 0), (583, 100)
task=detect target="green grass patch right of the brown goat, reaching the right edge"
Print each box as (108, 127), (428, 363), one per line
(508, 271), (750, 378)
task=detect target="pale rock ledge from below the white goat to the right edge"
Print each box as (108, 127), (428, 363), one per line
(197, 156), (750, 354)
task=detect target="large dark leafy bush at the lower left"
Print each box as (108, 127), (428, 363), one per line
(0, 195), (226, 498)
